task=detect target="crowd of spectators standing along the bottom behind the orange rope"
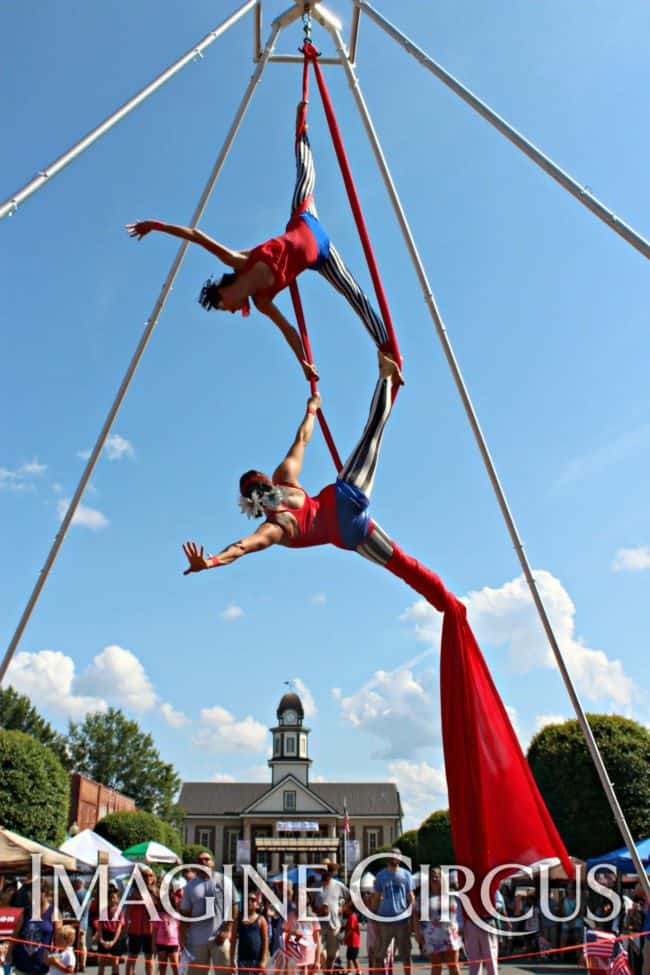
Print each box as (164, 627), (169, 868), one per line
(0, 850), (650, 975)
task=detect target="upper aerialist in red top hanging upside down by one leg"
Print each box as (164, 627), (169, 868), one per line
(127, 102), (401, 382)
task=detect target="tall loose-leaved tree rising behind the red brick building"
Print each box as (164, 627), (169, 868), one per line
(68, 708), (181, 816)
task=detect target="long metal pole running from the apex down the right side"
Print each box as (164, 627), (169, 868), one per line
(330, 21), (650, 899)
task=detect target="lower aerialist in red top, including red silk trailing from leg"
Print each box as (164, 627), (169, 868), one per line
(183, 351), (573, 900)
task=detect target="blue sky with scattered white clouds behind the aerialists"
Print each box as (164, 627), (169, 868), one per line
(0, 0), (650, 836)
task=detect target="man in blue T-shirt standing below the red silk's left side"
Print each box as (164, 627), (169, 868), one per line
(373, 849), (414, 975)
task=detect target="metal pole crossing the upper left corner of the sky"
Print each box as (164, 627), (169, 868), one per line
(0, 0), (257, 220)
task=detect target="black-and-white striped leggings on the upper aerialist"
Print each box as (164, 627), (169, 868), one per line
(291, 120), (388, 347)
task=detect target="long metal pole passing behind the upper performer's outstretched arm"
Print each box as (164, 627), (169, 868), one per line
(0, 24), (281, 684)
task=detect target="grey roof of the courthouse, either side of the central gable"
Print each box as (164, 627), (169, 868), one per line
(178, 782), (402, 817)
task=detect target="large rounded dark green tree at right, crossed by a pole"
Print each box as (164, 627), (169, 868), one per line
(528, 714), (650, 858)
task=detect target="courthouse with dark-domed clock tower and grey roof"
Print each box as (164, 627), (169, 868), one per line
(179, 692), (403, 873)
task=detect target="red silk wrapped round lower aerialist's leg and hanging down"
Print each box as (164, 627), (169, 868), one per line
(386, 543), (573, 914)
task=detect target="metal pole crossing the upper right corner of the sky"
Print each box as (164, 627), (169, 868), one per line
(353, 0), (650, 258)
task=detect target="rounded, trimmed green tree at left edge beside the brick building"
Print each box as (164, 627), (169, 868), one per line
(0, 729), (70, 846)
